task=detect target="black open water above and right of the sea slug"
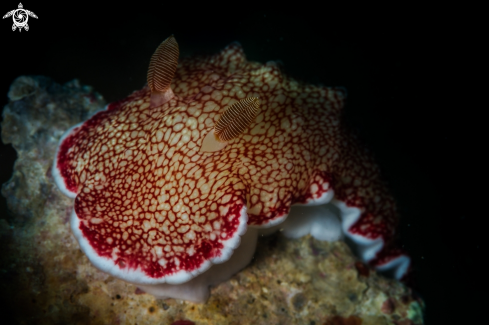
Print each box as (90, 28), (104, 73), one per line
(0, 2), (484, 324)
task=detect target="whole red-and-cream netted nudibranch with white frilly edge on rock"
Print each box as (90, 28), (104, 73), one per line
(52, 36), (410, 302)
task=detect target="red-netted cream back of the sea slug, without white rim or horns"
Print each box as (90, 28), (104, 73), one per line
(57, 44), (396, 278)
